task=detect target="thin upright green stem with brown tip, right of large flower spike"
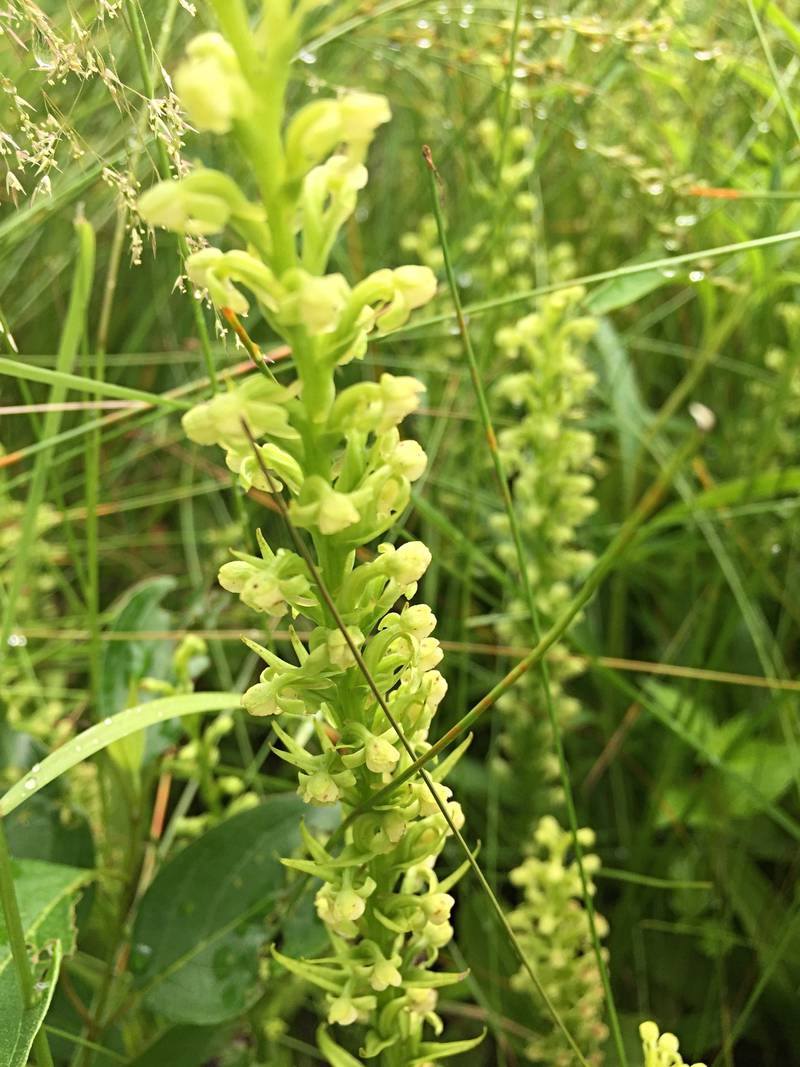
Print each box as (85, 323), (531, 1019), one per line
(422, 148), (627, 1067)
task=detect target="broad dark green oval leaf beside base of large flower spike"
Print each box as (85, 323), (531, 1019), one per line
(131, 796), (307, 1024)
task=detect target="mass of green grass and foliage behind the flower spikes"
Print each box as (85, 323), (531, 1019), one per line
(0, 0), (800, 1067)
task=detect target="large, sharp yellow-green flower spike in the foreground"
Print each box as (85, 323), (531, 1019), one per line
(140, 0), (476, 1065)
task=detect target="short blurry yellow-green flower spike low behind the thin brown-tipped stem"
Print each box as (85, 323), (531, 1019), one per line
(510, 815), (608, 1067)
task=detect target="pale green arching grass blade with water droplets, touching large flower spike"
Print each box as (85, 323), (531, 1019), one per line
(0, 692), (239, 817)
